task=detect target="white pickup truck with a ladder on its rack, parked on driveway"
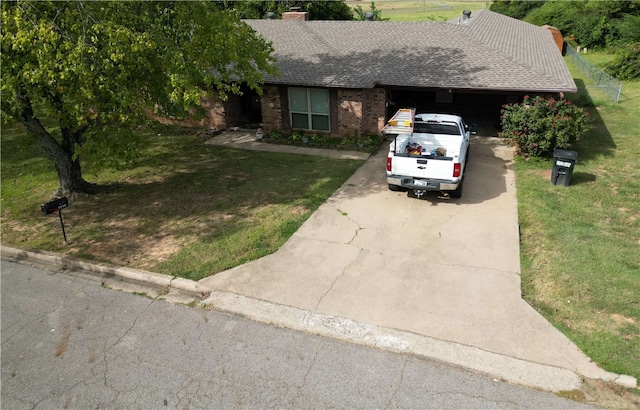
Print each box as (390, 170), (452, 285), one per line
(382, 109), (477, 199)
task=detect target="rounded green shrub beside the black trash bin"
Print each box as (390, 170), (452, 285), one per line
(500, 95), (589, 157)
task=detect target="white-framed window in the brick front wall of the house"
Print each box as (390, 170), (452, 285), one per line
(289, 87), (330, 131)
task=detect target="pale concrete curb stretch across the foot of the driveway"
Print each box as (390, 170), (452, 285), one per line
(205, 292), (582, 392)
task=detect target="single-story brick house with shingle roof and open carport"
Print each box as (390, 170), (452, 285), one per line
(202, 10), (576, 136)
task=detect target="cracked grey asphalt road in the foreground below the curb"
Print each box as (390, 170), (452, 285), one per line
(1, 260), (591, 409)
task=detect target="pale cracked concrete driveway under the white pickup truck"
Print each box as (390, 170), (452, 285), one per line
(201, 137), (614, 390)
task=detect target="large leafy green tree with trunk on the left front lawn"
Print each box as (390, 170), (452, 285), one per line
(1, 1), (276, 195)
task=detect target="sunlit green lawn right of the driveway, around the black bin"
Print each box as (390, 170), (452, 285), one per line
(516, 56), (640, 379)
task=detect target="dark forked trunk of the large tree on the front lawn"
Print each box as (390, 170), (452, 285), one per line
(19, 94), (98, 196)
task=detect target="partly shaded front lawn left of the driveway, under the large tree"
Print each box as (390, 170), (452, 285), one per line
(2, 124), (363, 280)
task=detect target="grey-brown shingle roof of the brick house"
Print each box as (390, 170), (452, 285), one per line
(246, 10), (576, 92)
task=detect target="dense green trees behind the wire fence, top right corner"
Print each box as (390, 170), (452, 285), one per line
(490, 0), (640, 80)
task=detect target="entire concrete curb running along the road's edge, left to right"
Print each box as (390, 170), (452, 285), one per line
(0, 244), (637, 392)
